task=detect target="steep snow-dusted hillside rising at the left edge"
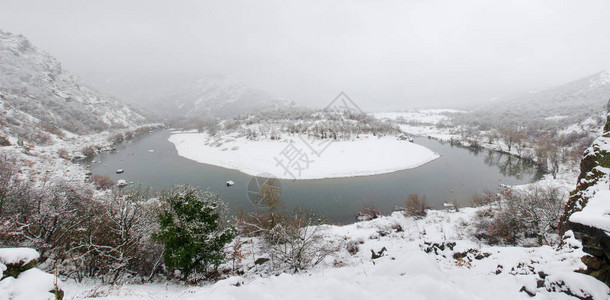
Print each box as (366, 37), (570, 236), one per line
(0, 31), (145, 144)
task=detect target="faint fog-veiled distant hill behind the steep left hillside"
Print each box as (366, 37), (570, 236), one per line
(82, 74), (286, 119)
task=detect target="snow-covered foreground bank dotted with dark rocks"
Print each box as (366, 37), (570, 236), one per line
(63, 191), (610, 299)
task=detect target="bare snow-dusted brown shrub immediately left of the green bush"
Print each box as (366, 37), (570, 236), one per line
(72, 188), (162, 283)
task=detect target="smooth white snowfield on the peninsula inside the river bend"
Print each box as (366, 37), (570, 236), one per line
(169, 132), (439, 179)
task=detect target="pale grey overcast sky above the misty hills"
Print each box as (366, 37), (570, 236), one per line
(0, 0), (610, 109)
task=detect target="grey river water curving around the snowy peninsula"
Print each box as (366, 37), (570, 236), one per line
(82, 131), (541, 223)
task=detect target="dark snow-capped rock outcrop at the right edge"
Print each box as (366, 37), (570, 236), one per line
(560, 101), (610, 286)
